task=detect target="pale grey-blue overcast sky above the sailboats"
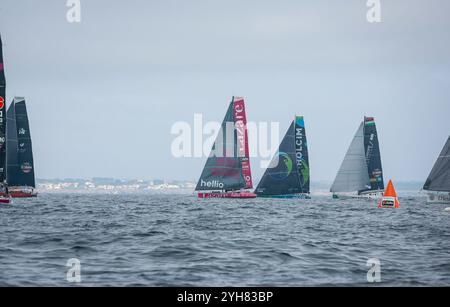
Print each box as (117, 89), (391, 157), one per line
(0, 0), (450, 181)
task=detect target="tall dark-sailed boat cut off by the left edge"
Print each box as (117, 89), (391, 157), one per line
(0, 36), (10, 204)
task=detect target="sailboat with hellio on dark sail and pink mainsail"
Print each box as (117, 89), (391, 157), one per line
(195, 97), (256, 198)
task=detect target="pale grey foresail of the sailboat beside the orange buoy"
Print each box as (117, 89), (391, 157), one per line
(331, 123), (370, 192)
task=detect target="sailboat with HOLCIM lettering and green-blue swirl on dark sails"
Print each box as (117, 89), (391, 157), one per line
(256, 116), (310, 199)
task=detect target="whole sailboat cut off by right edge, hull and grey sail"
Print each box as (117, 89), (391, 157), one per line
(423, 136), (450, 204)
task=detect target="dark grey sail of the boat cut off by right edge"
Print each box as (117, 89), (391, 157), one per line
(423, 137), (450, 192)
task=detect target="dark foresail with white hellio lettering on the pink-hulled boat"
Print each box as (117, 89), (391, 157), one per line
(195, 97), (251, 191)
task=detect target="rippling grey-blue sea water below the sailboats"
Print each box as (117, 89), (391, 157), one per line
(0, 194), (450, 286)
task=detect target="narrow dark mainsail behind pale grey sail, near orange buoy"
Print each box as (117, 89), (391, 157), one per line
(364, 117), (384, 191)
